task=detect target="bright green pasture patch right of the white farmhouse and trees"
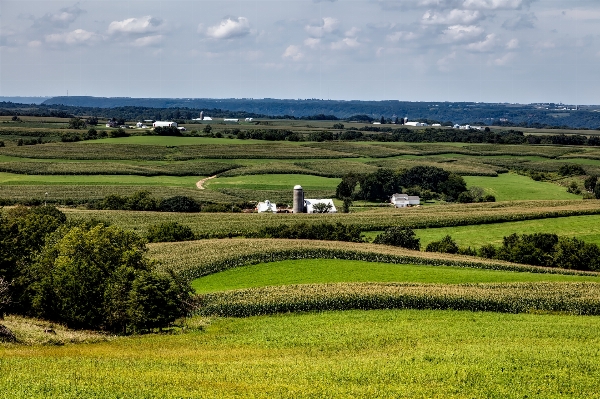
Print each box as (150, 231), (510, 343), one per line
(464, 173), (581, 201)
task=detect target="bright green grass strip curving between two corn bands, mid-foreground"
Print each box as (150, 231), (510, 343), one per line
(192, 259), (598, 292)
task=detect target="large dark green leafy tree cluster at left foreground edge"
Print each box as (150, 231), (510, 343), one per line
(0, 207), (191, 333)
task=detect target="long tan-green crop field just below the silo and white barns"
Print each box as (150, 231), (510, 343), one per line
(67, 202), (600, 236)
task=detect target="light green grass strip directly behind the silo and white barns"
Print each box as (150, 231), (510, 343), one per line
(206, 174), (340, 193)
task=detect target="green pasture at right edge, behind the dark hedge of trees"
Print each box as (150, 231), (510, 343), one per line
(415, 215), (600, 248)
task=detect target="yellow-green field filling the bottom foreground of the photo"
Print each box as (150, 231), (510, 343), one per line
(0, 310), (600, 399)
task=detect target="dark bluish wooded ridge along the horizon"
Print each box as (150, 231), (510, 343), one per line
(36, 96), (600, 129)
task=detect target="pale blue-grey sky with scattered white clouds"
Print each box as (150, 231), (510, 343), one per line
(0, 0), (600, 104)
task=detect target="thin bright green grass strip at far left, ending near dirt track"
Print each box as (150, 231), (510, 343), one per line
(0, 172), (199, 188)
